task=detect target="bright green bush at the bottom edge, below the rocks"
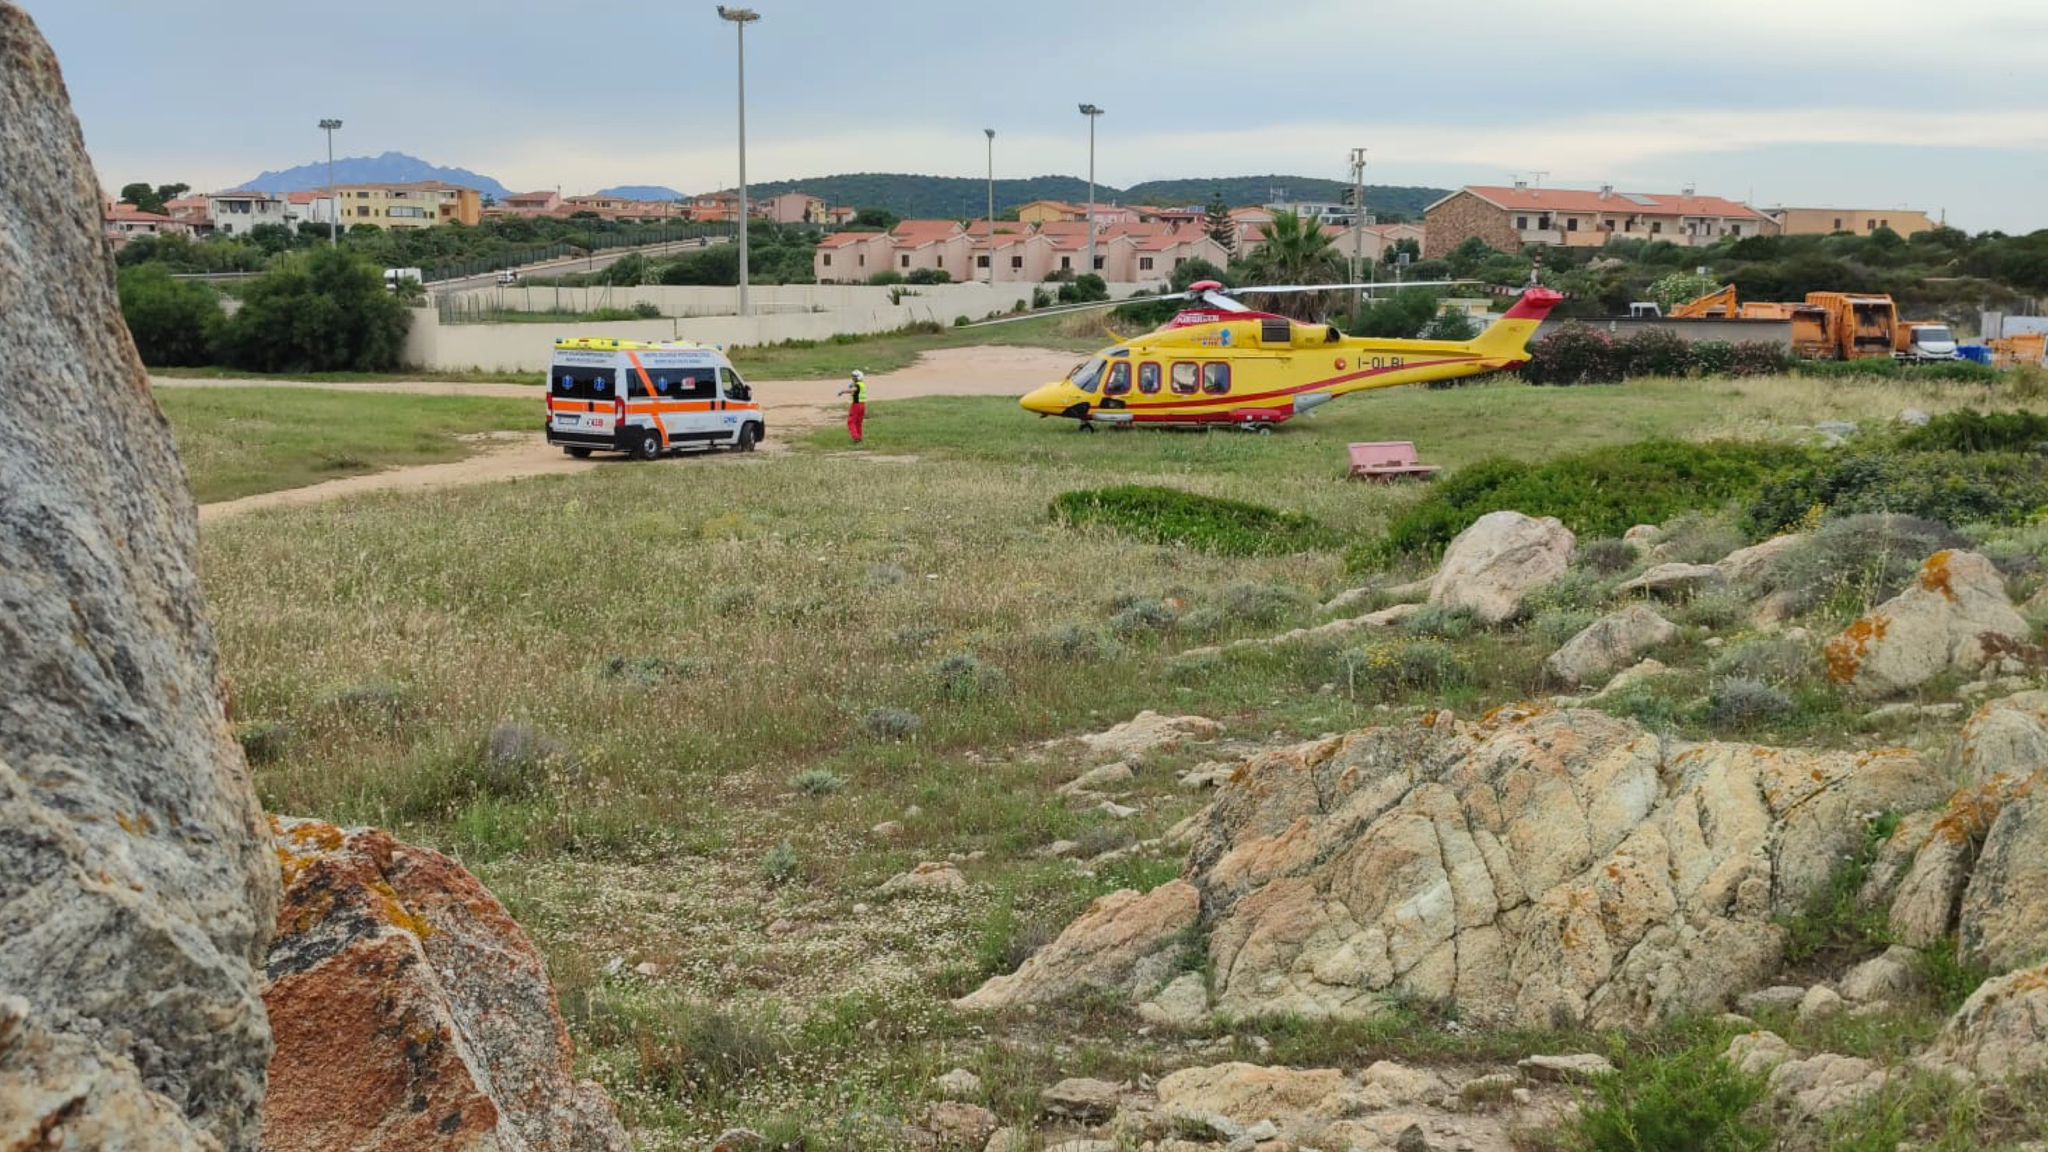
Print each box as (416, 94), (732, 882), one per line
(1573, 1039), (1772, 1152)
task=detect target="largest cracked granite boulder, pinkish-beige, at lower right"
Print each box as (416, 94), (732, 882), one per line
(974, 709), (1948, 1027)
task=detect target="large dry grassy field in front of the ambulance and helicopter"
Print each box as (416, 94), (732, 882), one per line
(195, 364), (2048, 1148)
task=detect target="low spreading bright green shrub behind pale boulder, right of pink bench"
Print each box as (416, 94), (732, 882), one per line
(1358, 441), (1806, 566)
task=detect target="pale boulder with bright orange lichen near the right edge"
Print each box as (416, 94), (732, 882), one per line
(1827, 551), (2030, 697)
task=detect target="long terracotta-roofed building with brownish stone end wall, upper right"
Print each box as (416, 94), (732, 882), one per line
(1423, 180), (1778, 258)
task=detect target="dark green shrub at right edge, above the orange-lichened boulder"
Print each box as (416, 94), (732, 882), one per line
(1745, 449), (2048, 537)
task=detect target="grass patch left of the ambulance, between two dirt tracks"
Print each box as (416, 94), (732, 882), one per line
(156, 387), (539, 504)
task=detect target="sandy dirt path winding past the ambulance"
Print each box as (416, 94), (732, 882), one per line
(176, 346), (1075, 523)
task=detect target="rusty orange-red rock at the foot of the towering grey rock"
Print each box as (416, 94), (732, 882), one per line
(264, 820), (627, 1152)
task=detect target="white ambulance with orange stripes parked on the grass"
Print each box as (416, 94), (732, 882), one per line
(547, 338), (768, 459)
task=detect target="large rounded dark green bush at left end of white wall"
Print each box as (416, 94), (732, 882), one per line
(219, 248), (412, 371)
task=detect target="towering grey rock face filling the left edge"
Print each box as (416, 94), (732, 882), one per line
(0, 0), (276, 1148)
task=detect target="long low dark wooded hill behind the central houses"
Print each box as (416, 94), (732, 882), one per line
(729, 172), (1450, 219)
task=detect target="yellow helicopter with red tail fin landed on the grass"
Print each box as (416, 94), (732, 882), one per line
(1018, 281), (1565, 433)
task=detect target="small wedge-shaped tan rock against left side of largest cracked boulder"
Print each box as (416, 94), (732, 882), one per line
(952, 879), (1200, 1013)
